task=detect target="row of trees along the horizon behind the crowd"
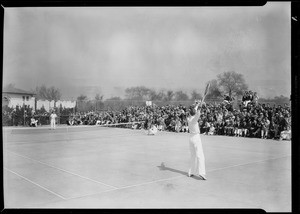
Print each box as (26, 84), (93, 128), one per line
(4, 71), (288, 103)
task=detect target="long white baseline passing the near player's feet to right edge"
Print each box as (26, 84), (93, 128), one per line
(63, 155), (290, 200)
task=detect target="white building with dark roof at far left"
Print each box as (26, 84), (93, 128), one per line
(2, 88), (35, 110)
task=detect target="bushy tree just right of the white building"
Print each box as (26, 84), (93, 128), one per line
(35, 85), (61, 102)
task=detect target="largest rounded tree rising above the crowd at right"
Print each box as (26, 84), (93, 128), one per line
(217, 71), (248, 97)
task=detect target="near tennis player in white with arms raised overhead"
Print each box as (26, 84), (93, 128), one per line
(187, 101), (206, 180)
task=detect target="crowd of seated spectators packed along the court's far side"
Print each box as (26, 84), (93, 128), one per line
(64, 91), (291, 140)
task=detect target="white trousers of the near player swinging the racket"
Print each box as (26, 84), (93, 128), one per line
(189, 134), (206, 175)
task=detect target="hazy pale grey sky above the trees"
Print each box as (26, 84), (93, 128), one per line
(3, 2), (291, 99)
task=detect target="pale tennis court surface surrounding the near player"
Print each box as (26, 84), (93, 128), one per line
(3, 127), (291, 212)
